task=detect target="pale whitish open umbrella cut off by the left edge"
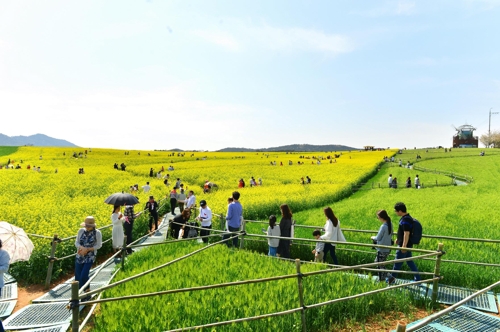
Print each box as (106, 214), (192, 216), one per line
(0, 221), (35, 264)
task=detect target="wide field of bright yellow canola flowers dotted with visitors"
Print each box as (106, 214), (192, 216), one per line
(0, 147), (393, 237)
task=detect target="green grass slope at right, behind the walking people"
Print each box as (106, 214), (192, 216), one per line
(282, 149), (500, 289)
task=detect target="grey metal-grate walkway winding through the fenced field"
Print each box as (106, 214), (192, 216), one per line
(0, 213), (500, 332)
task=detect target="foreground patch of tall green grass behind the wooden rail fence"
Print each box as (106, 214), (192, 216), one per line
(95, 242), (411, 331)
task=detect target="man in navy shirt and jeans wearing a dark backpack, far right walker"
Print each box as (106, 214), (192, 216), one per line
(386, 202), (420, 285)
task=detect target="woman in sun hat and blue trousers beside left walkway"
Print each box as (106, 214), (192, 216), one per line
(75, 216), (102, 292)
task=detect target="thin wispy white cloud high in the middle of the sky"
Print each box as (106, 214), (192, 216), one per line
(194, 20), (355, 55)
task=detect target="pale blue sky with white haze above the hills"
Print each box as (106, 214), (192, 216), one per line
(0, 0), (500, 150)
